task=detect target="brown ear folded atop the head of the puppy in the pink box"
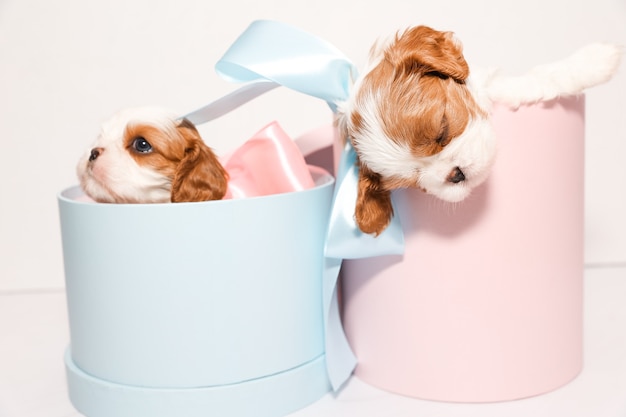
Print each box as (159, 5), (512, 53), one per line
(386, 26), (469, 82)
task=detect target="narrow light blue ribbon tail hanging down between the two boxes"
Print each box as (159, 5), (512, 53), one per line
(323, 258), (357, 392)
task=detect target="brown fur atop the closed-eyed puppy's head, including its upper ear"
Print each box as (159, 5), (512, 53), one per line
(351, 26), (481, 157)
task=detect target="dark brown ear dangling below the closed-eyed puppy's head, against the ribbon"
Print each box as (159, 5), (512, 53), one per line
(354, 164), (393, 236)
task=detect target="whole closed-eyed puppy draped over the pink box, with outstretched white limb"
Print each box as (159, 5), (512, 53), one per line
(337, 26), (621, 235)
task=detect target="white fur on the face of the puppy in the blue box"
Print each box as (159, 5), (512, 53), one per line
(77, 107), (176, 203)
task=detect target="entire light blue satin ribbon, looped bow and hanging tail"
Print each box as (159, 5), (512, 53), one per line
(186, 20), (404, 391)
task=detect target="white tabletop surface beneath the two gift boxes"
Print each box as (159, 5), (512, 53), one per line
(0, 266), (626, 417)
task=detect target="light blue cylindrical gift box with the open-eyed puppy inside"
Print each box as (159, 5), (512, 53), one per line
(58, 167), (334, 417)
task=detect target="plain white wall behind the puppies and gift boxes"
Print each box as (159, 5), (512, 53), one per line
(0, 0), (626, 292)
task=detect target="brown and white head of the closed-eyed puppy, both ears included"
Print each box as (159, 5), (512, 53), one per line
(339, 26), (495, 234)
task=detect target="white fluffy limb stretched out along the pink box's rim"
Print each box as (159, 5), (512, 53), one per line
(487, 43), (623, 108)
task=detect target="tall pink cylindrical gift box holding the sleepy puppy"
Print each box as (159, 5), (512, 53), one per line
(342, 96), (584, 402)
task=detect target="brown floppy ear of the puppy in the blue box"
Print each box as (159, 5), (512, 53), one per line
(172, 119), (228, 203)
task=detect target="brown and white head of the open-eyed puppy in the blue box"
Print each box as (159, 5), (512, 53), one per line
(77, 107), (228, 203)
